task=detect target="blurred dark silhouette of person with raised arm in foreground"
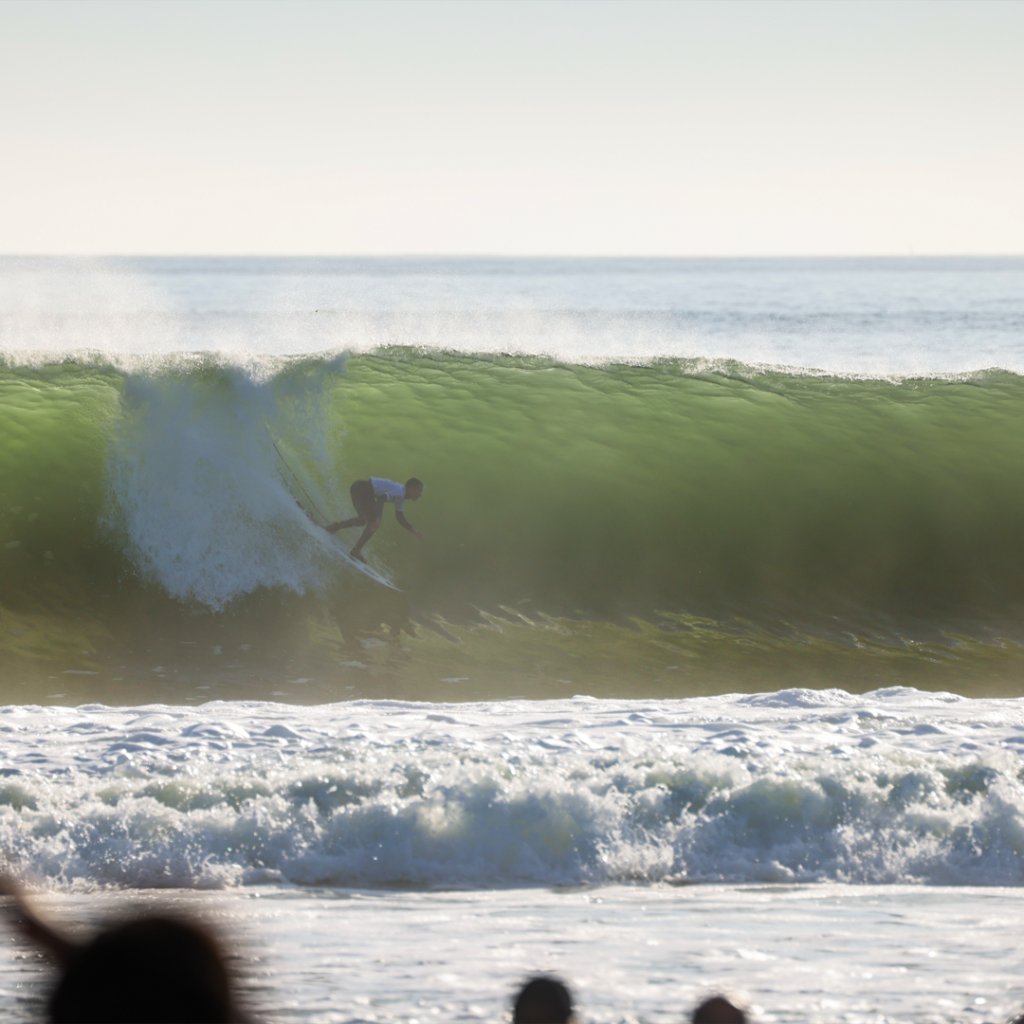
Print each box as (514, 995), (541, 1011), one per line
(0, 877), (246, 1024)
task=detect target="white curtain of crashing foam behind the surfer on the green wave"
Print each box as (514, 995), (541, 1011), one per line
(99, 359), (393, 610)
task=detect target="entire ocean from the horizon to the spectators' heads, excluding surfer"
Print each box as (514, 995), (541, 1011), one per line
(0, 257), (1024, 1024)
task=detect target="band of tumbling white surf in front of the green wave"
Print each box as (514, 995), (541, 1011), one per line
(6, 688), (1024, 888)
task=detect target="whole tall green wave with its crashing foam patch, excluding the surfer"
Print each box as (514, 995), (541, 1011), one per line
(0, 349), (1024, 700)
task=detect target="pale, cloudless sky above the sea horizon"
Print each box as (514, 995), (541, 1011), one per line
(0, 0), (1024, 256)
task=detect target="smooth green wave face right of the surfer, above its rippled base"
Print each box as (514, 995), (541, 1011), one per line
(348, 358), (1024, 620)
